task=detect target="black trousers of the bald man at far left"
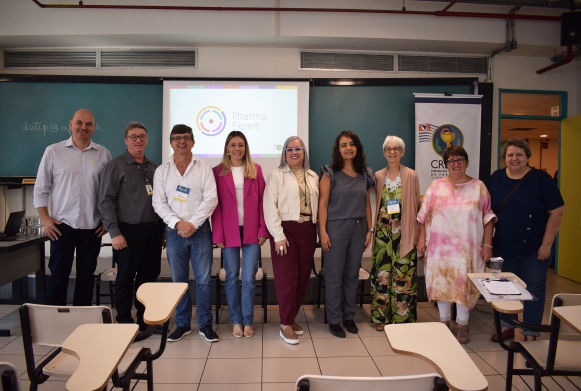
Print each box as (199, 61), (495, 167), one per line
(46, 223), (101, 306)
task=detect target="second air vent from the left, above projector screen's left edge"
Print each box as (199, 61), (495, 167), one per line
(101, 49), (197, 68)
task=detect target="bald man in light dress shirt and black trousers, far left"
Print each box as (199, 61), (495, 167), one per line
(34, 109), (111, 306)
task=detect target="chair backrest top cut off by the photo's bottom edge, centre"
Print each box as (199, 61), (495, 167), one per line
(297, 373), (441, 391)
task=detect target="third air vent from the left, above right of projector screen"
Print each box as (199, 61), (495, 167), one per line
(300, 51), (395, 72)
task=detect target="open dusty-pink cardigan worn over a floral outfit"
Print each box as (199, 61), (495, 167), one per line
(372, 164), (420, 257)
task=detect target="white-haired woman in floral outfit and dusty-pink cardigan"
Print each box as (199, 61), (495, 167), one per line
(371, 136), (420, 331)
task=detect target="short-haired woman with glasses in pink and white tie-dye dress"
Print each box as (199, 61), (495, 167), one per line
(417, 145), (496, 343)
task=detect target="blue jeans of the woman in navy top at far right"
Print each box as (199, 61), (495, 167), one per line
(501, 245), (555, 337)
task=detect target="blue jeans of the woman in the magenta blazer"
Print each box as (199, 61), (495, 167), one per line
(222, 227), (260, 326)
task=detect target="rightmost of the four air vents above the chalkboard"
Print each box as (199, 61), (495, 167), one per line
(397, 54), (488, 74)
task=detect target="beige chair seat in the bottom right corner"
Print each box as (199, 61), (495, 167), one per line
(518, 340), (581, 371)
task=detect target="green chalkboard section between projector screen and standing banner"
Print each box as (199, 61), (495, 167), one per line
(309, 85), (470, 174)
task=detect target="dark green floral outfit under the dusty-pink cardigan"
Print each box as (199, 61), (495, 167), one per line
(371, 176), (417, 324)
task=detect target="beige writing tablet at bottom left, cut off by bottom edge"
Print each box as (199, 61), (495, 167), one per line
(61, 323), (139, 391)
